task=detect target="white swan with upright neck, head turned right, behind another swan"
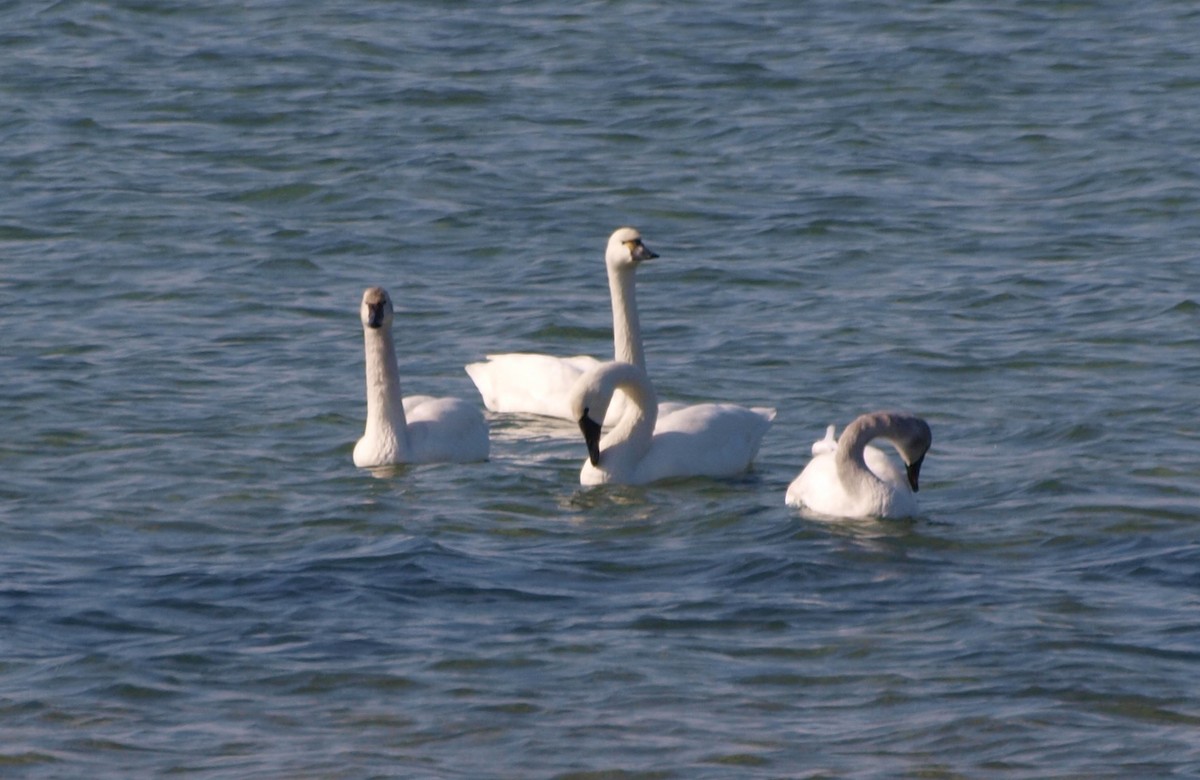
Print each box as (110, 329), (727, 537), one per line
(466, 228), (658, 425)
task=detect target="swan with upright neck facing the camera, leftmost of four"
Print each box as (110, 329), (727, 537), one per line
(354, 287), (488, 468)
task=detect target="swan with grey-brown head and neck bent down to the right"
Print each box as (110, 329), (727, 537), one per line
(786, 412), (934, 517)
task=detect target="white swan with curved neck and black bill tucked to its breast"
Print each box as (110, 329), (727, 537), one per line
(568, 361), (775, 485)
